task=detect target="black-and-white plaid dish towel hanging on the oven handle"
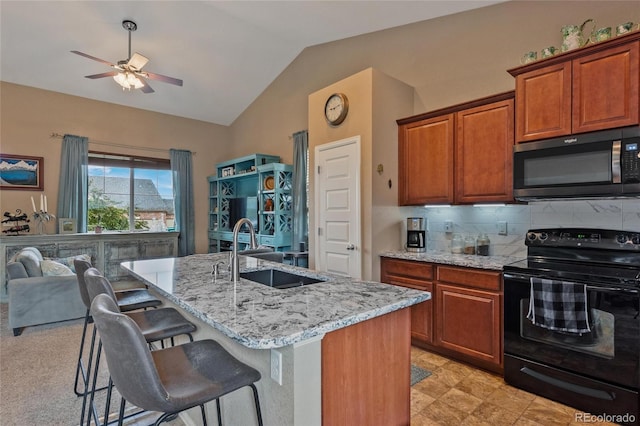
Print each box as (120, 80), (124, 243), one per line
(527, 278), (591, 333)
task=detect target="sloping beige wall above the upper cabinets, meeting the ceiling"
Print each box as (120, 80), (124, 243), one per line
(232, 0), (640, 162)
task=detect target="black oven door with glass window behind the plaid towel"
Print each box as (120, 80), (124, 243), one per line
(504, 273), (640, 389)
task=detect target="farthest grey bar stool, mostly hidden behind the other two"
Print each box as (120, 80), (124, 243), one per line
(73, 259), (162, 396)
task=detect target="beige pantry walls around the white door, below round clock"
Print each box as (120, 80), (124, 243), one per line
(309, 68), (413, 280)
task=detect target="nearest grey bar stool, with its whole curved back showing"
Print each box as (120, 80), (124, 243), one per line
(91, 295), (262, 426)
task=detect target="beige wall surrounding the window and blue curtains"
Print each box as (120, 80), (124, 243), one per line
(0, 82), (231, 253)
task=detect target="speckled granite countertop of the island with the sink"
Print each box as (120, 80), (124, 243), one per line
(121, 253), (431, 349)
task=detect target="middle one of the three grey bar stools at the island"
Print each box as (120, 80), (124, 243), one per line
(80, 268), (196, 424)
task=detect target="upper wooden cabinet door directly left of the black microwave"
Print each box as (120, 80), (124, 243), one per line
(454, 99), (514, 203)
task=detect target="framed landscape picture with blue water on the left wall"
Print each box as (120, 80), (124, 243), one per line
(0, 154), (44, 191)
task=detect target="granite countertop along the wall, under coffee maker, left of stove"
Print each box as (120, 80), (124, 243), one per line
(380, 250), (522, 271)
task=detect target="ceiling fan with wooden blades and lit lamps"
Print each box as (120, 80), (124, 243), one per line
(71, 20), (182, 93)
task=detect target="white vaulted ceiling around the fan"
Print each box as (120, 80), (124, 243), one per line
(0, 0), (500, 125)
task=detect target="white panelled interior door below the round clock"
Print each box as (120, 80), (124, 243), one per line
(315, 136), (362, 279)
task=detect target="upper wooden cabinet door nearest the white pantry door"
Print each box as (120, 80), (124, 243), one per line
(398, 113), (454, 206)
